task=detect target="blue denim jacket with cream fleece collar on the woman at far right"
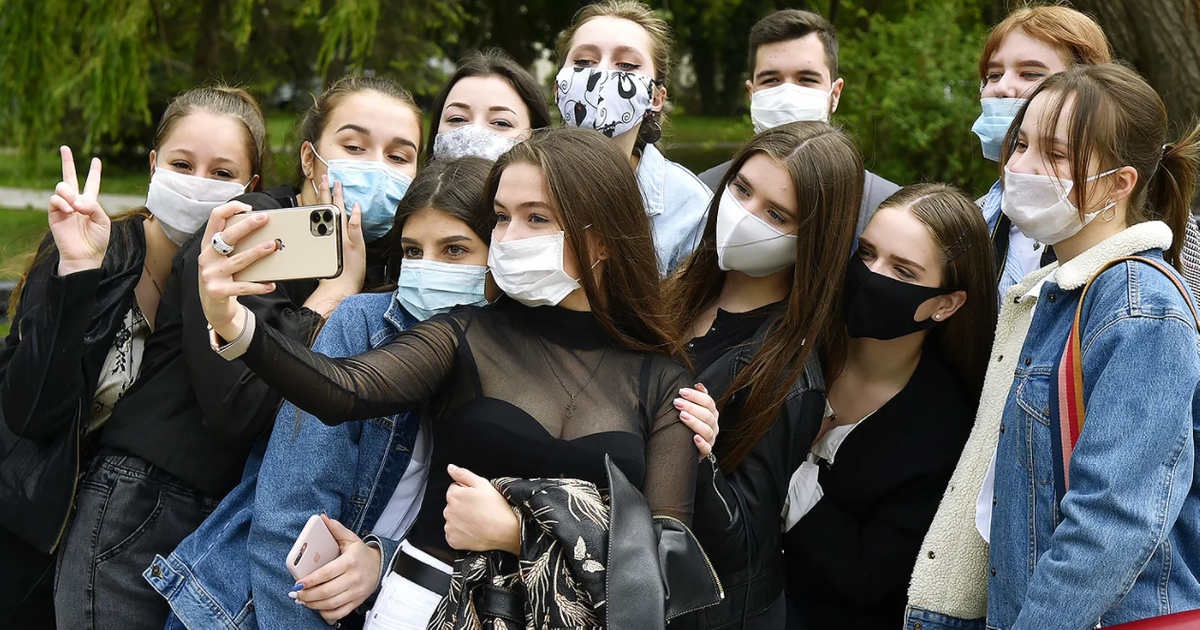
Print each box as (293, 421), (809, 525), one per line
(988, 223), (1200, 630)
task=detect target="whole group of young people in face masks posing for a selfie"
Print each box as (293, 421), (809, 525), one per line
(0, 0), (1200, 630)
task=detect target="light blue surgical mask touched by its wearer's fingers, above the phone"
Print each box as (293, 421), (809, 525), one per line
(312, 146), (413, 242)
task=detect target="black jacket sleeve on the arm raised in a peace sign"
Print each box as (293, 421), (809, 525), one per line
(0, 216), (146, 552)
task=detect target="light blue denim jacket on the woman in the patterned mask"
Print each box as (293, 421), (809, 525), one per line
(637, 144), (713, 277)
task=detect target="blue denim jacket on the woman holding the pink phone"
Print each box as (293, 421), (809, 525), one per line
(143, 294), (419, 629)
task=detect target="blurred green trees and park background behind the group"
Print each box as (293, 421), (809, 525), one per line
(0, 0), (1200, 331)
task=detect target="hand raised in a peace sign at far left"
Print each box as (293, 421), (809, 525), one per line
(49, 145), (112, 276)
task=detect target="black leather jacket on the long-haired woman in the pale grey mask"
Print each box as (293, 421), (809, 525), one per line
(692, 314), (824, 629)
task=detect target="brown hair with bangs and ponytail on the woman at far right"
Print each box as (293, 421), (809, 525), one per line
(1000, 64), (1200, 271)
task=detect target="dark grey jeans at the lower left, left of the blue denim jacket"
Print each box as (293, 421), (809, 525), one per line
(54, 455), (217, 630)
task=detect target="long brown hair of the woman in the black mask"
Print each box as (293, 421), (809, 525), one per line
(878, 184), (997, 403)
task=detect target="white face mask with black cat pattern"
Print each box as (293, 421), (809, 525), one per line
(554, 66), (654, 138)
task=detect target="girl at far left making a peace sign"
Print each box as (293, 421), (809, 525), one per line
(0, 86), (265, 628)
